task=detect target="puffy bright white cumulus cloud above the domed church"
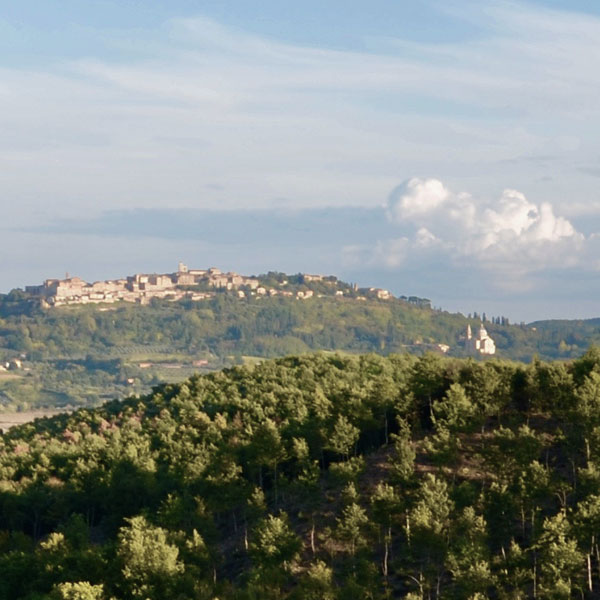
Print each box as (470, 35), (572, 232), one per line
(376, 178), (585, 278)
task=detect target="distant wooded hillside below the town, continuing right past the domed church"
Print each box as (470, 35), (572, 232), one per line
(0, 273), (600, 410)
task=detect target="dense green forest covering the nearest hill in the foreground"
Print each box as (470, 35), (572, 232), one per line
(0, 348), (600, 600)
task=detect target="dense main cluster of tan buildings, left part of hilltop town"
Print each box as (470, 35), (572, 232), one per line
(25, 263), (259, 306)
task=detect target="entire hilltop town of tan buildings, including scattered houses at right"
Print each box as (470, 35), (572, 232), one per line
(25, 263), (393, 308)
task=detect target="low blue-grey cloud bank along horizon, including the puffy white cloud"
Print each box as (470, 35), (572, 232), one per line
(5, 185), (600, 321)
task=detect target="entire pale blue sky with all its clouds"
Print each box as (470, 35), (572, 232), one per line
(0, 0), (600, 321)
